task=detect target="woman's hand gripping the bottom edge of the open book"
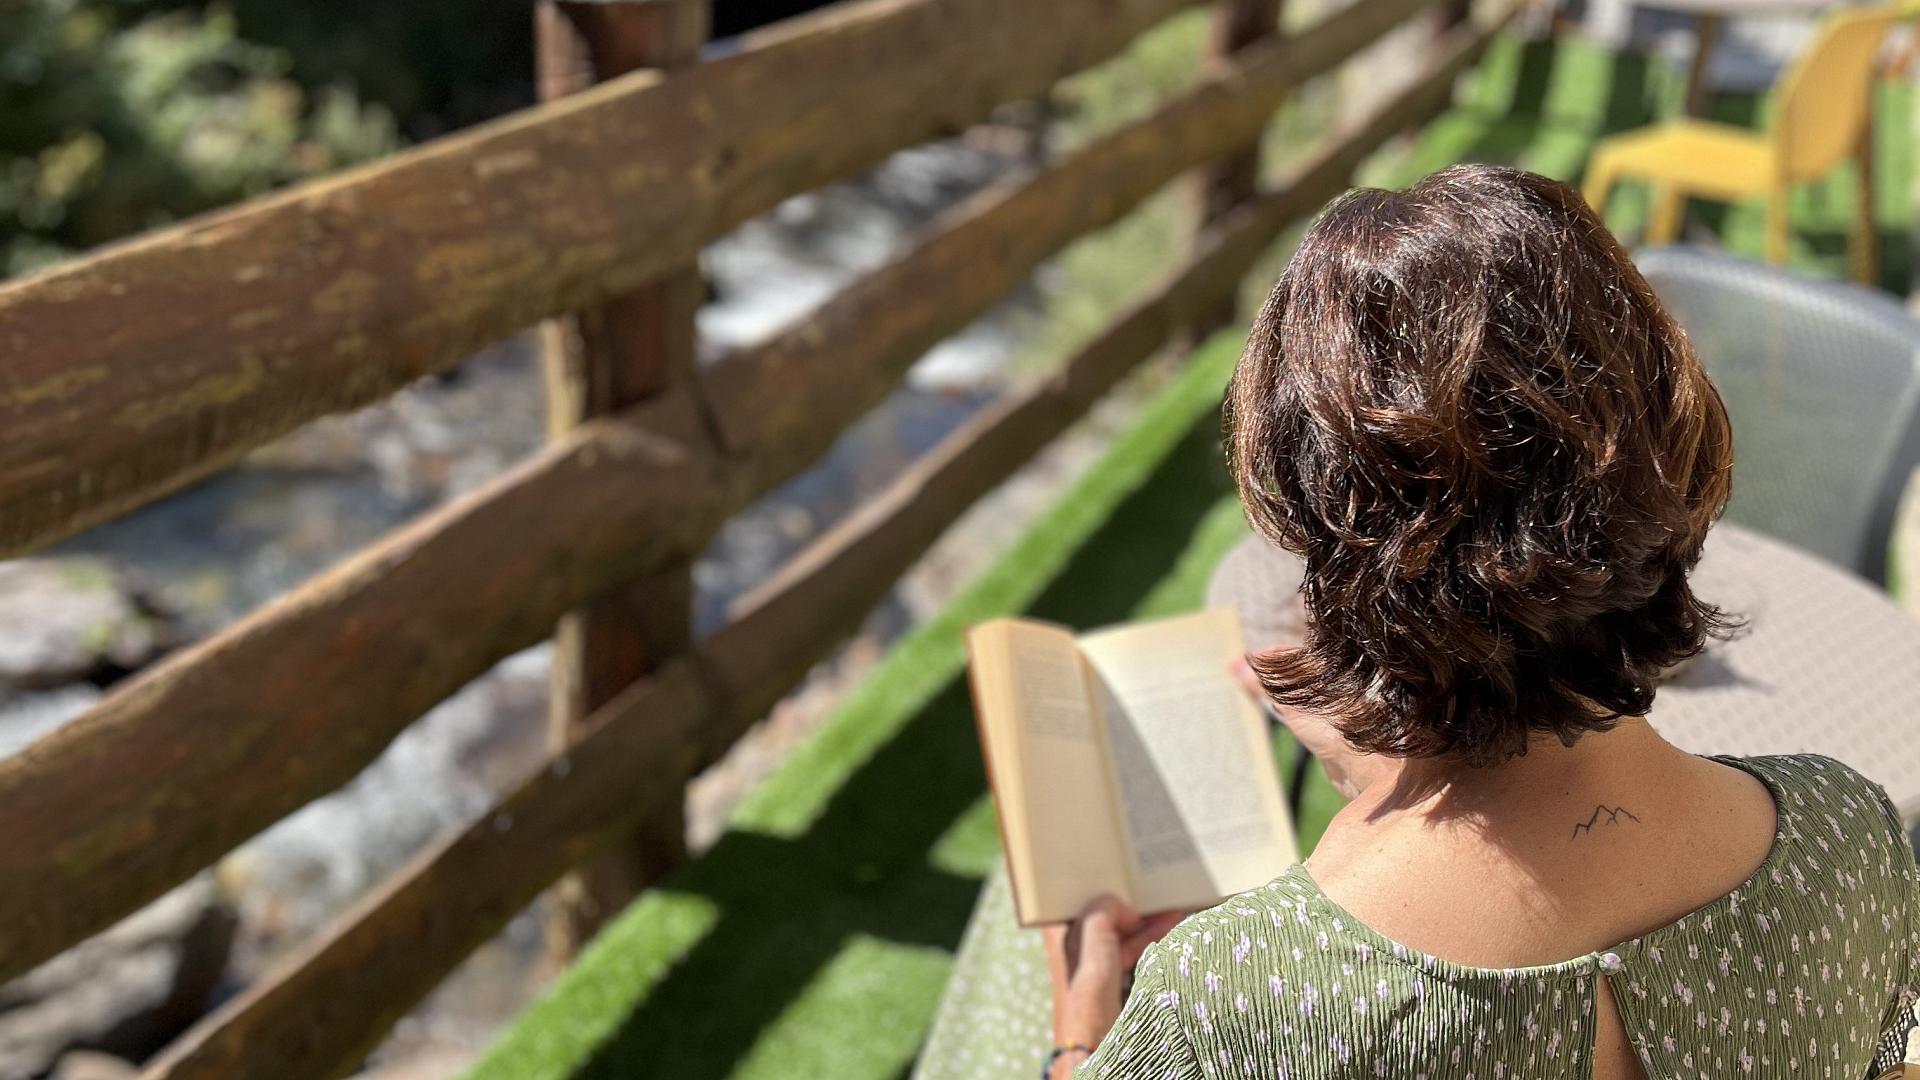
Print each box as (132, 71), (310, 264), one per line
(1046, 896), (1185, 1076)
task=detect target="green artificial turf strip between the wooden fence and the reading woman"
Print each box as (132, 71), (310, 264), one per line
(472, 334), (1334, 1080)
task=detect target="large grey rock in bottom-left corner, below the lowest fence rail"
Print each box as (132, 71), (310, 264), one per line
(0, 874), (234, 1076)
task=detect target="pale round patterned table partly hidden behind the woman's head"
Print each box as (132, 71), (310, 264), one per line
(1208, 523), (1920, 821)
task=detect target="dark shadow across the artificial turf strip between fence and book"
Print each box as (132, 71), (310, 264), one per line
(574, 405), (1229, 1080)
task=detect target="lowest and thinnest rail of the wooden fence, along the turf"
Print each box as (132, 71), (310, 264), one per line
(144, 21), (1492, 1080)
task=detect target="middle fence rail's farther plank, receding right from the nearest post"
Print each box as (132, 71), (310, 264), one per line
(705, 0), (1432, 488)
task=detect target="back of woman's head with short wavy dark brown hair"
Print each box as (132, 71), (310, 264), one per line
(1227, 165), (1732, 763)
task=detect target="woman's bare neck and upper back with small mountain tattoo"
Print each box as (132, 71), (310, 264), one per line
(1308, 721), (1776, 967)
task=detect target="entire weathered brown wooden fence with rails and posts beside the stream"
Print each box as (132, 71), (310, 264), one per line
(0, 0), (1511, 1080)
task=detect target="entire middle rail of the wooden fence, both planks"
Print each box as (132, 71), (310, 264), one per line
(0, 0), (1432, 976)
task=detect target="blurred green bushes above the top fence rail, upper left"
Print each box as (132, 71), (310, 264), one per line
(0, 0), (532, 275)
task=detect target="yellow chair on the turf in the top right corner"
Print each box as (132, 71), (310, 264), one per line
(1584, 4), (1914, 284)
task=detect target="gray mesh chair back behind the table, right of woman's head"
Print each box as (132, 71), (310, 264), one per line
(1636, 248), (1920, 586)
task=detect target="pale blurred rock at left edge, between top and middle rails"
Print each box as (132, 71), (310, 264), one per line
(0, 557), (177, 692)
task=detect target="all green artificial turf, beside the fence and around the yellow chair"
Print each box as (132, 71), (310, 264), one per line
(472, 27), (1912, 1080)
